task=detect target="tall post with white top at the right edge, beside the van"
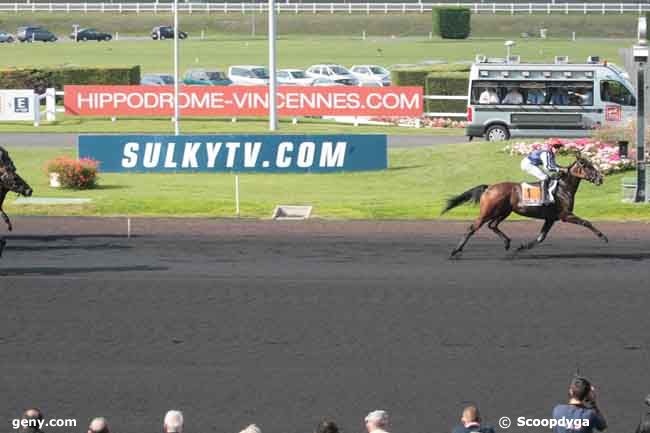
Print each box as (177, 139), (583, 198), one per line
(632, 17), (648, 203)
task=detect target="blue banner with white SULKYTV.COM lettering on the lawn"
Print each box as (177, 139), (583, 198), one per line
(79, 135), (388, 173)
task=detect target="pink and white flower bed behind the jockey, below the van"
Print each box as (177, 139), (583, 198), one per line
(503, 138), (635, 174)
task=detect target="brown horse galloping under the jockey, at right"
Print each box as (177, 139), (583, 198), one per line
(442, 155), (608, 258)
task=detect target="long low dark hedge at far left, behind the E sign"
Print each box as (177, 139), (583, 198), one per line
(0, 66), (140, 93)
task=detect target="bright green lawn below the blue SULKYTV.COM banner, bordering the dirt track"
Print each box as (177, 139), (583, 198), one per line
(5, 143), (650, 220)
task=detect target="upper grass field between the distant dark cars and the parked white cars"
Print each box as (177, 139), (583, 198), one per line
(0, 35), (632, 74)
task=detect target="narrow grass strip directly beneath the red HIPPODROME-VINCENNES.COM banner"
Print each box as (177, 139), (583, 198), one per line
(0, 114), (464, 134)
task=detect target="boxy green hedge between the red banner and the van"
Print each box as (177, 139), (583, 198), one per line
(424, 72), (469, 113)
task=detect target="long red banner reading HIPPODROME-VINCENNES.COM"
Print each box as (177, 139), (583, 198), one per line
(64, 86), (422, 117)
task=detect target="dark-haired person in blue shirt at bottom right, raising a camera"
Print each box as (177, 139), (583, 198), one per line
(553, 377), (607, 433)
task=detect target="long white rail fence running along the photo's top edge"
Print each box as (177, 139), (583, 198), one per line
(0, 2), (650, 15)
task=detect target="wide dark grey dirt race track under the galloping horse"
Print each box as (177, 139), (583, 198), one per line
(0, 218), (650, 433)
